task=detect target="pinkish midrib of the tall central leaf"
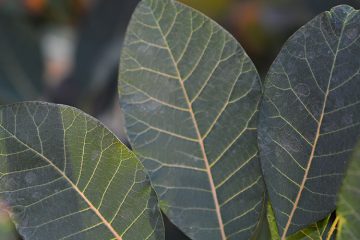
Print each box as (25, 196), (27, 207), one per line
(148, 2), (226, 240)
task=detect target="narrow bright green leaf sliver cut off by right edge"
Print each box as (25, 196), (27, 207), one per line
(336, 144), (360, 240)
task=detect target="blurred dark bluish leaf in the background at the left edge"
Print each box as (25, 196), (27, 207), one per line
(0, 13), (43, 104)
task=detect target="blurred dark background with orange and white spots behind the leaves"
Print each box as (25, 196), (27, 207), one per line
(0, 0), (360, 240)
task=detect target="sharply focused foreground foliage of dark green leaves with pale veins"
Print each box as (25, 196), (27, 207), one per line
(0, 0), (360, 240)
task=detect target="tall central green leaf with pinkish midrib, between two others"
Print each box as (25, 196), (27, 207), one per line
(119, 0), (265, 240)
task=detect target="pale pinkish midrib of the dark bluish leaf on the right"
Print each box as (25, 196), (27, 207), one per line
(281, 14), (350, 240)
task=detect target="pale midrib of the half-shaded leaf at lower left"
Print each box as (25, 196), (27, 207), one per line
(0, 124), (122, 240)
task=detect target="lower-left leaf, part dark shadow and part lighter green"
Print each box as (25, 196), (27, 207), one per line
(0, 102), (164, 240)
